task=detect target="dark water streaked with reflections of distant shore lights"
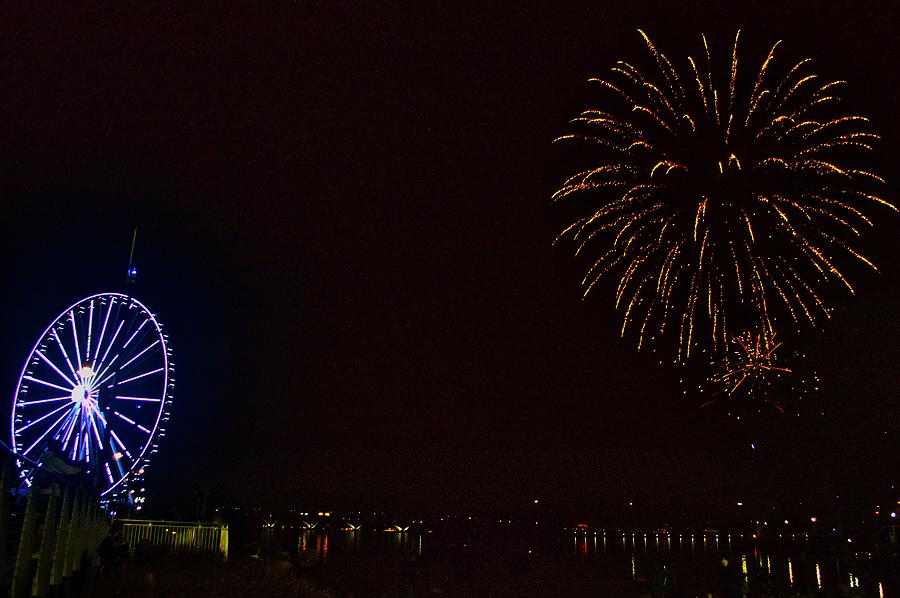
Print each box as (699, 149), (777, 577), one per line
(255, 527), (900, 598)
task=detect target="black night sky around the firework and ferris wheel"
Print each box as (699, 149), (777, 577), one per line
(0, 2), (900, 520)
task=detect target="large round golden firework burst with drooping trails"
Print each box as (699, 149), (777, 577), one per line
(554, 31), (896, 361)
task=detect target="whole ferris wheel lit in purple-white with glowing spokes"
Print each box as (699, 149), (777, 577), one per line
(10, 293), (175, 497)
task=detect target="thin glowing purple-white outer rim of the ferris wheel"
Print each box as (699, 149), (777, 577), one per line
(9, 291), (172, 497)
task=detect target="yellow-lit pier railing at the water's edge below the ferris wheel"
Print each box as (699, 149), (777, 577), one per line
(121, 519), (228, 560)
